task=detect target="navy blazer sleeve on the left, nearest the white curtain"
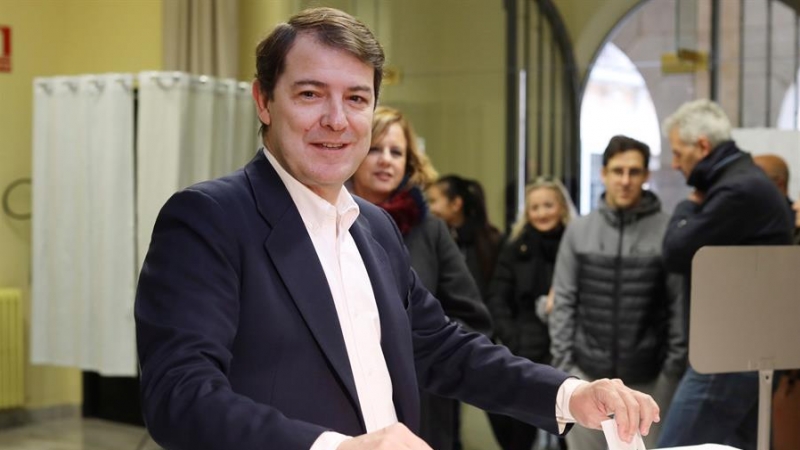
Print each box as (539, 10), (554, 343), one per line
(135, 190), (326, 450)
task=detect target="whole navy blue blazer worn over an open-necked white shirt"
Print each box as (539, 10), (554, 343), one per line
(135, 152), (567, 450)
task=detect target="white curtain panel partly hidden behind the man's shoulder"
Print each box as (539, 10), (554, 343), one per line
(136, 72), (260, 267)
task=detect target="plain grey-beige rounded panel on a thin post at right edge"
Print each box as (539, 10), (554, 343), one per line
(689, 246), (800, 450)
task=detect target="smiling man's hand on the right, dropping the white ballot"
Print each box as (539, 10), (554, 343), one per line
(569, 378), (661, 442)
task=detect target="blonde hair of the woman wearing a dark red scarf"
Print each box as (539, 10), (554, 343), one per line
(372, 106), (439, 190)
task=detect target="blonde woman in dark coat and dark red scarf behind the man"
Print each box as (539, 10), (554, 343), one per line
(350, 106), (492, 450)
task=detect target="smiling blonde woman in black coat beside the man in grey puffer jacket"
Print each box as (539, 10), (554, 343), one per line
(488, 177), (575, 450)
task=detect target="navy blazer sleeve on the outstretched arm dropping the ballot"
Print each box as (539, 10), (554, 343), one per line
(376, 205), (570, 434)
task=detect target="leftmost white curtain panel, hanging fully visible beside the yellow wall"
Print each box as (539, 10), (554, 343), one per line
(31, 74), (136, 376)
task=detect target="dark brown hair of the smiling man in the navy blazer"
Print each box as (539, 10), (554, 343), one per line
(256, 8), (385, 134)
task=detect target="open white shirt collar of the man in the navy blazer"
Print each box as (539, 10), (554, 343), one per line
(262, 147), (360, 236)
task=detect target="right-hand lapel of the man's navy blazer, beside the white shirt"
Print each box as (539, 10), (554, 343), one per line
(350, 216), (419, 430)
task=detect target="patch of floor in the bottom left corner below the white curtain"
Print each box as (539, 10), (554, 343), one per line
(0, 418), (161, 450)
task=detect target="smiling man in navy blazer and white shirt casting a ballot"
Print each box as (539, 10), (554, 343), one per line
(135, 8), (658, 450)
